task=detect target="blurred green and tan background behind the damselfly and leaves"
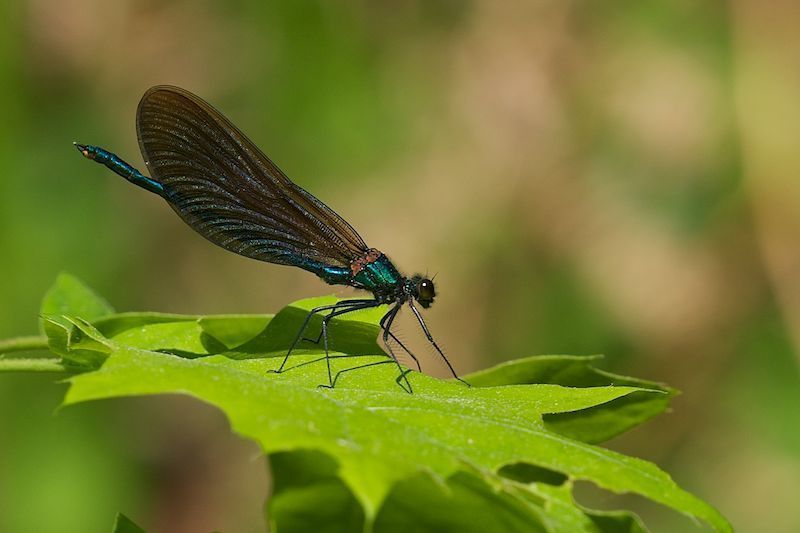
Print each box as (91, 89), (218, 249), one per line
(0, 0), (800, 533)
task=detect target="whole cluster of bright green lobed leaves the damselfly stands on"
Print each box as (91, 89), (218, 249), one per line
(0, 276), (730, 532)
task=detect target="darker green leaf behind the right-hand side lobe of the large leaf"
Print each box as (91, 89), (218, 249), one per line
(465, 355), (676, 444)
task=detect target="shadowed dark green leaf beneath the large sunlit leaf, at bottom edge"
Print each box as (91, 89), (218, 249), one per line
(268, 450), (646, 533)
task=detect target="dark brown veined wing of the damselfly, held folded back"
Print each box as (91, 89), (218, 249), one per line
(136, 86), (367, 267)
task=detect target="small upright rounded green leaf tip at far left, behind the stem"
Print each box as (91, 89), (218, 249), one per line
(39, 273), (114, 325)
